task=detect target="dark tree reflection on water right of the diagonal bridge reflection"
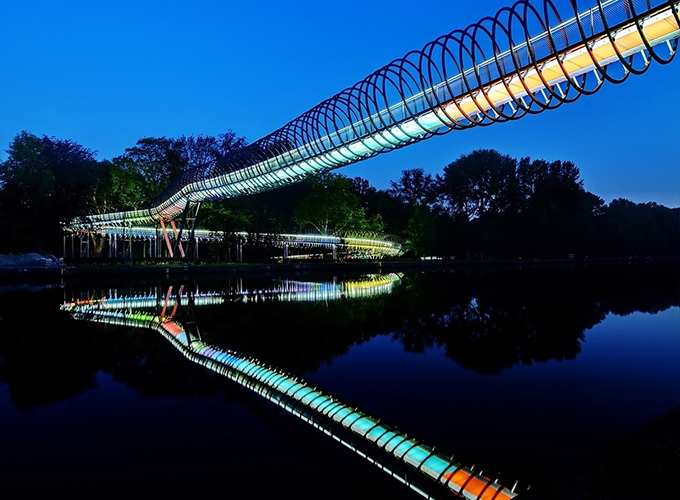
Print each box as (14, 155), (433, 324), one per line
(191, 265), (678, 373)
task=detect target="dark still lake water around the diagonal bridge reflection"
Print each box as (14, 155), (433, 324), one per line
(0, 264), (680, 499)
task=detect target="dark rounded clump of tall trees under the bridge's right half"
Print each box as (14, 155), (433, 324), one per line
(438, 150), (620, 258)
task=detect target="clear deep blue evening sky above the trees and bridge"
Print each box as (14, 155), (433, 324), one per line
(0, 0), (680, 207)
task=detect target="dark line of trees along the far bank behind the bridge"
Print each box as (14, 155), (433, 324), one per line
(0, 130), (680, 259)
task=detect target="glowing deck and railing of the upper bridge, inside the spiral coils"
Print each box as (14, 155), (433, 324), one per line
(72, 0), (680, 227)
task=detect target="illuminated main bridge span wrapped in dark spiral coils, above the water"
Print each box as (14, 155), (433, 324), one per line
(69, 0), (680, 258)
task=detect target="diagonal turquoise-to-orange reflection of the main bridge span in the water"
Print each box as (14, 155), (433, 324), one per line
(62, 277), (517, 500)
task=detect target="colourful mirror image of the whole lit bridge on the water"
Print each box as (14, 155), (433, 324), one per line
(62, 273), (518, 500)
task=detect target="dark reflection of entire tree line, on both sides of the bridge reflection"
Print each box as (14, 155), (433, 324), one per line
(0, 264), (680, 411)
